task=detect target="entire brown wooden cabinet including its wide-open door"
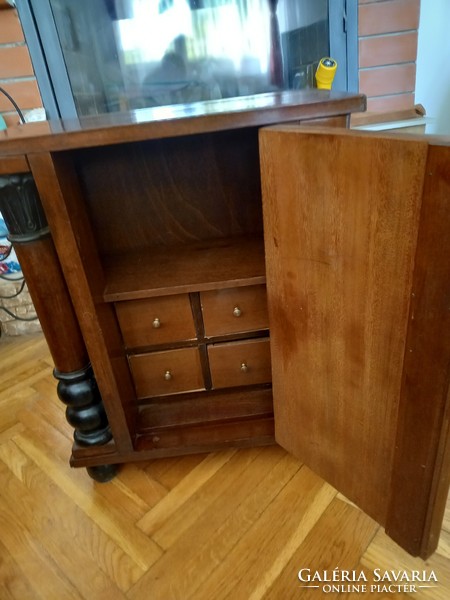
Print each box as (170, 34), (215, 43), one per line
(0, 91), (450, 556)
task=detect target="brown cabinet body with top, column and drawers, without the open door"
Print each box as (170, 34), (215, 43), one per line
(1, 90), (365, 479)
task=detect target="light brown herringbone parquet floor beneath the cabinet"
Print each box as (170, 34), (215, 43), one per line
(0, 334), (450, 600)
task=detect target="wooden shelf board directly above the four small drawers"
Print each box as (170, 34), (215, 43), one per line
(104, 236), (266, 302)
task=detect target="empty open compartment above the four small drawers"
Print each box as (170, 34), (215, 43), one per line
(70, 128), (264, 301)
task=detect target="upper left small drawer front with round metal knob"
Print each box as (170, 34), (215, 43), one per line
(115, 294), (196, 348)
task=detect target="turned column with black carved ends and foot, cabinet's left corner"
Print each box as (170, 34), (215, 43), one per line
(0, 173), (116, 481)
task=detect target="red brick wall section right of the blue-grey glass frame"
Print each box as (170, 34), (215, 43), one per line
(358, 0), (420, 112)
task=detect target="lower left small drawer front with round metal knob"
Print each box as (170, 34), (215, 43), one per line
(129, 348), (205, 398)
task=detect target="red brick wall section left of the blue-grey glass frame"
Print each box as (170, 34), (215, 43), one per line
(0, 0), (42, 125)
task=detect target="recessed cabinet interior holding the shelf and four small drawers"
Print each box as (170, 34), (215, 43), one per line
(61, 127), (273, 448)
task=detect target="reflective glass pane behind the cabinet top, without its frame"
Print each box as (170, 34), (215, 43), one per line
(50, 0), (329, 115)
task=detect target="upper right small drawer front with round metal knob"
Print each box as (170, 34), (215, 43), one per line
(201, 285), (269, 336)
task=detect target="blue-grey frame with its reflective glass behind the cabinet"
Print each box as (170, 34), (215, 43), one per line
(16, 0), (358, 118)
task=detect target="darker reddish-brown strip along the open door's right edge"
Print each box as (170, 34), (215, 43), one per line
(386, 146), (450, 558)
